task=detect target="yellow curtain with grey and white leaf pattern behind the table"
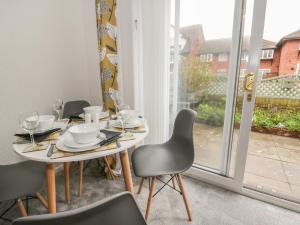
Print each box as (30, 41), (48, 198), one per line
(96, 0), (118, 111)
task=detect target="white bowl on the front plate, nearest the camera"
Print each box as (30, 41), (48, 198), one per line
(69, 123), (100, 144)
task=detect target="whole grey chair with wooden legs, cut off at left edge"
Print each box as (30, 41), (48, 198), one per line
(0, 161), (47, 221)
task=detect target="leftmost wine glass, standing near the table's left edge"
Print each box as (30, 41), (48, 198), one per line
(19, 111), (39, 149)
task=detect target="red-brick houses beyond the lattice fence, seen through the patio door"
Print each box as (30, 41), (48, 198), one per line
(180, 25), (300, 78)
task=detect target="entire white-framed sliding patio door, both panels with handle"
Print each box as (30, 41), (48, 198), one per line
(170, 0), (300, 210)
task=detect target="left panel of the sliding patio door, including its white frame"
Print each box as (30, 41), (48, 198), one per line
(170, 0), (244, 176)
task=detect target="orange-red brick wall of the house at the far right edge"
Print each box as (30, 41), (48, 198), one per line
(279, 40), (300, 75)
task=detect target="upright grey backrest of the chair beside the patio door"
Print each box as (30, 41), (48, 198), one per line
(168, 109), (197, 167)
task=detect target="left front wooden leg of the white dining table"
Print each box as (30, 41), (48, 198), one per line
(46, 163), (56, 213)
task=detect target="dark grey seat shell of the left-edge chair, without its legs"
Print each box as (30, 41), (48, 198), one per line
(0, 161), (45, 202)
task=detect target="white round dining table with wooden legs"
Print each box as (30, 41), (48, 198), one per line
(13, 125), (149, 213)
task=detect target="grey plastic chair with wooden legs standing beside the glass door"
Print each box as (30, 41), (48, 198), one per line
(132, 109), (196, 221)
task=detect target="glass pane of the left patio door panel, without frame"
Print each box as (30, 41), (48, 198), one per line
(170, 0), (235, 171)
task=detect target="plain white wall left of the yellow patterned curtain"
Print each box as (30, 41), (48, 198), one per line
(0, 0), (101, 164)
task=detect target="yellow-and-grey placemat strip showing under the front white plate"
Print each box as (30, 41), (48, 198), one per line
(50, 142), (117, 159)
